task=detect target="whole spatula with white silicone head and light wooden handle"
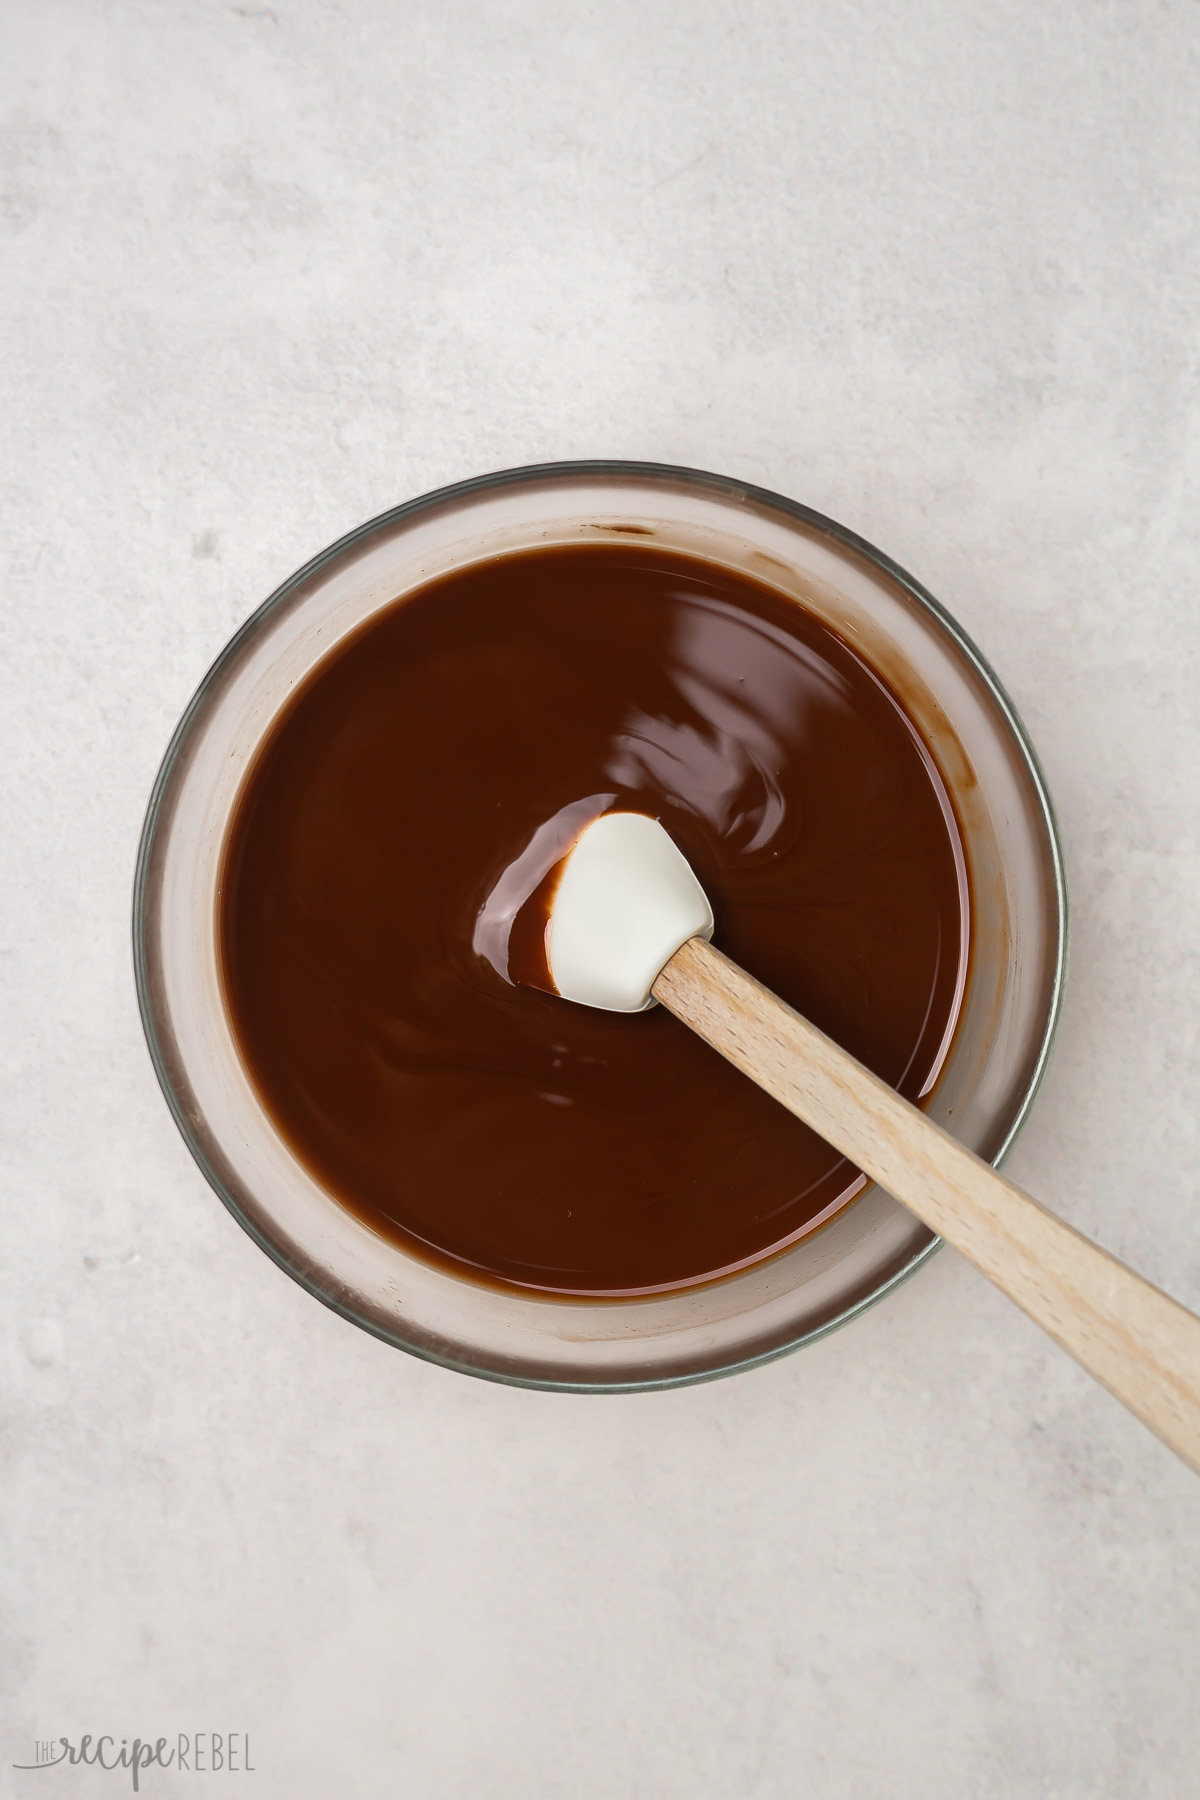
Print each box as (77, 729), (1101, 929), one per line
(545, 812), (1200, 1471)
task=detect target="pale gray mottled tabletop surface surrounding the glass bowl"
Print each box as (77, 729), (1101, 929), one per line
(0, 0), (1200, 1800)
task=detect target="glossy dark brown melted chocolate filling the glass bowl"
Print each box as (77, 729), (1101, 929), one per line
(219, 544), (966, 1294)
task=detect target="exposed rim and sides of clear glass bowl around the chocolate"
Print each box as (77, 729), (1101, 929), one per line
(133, 463), (1067, 1391)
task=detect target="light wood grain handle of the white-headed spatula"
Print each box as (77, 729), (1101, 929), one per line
(653, 938), (1200, 1471)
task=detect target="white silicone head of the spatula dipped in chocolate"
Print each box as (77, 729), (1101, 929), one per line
(547, 812), (712, 1012)
